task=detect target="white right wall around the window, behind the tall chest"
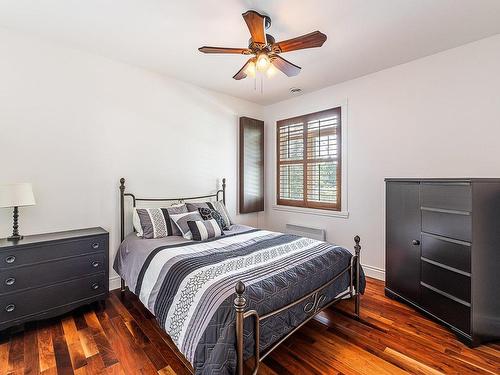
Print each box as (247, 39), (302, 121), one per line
(259, 35), (500, 278)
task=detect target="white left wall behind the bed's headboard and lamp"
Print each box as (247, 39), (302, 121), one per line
(0, 30), (262, 286)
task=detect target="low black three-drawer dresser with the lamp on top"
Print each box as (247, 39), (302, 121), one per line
(0, 228), (109, 330)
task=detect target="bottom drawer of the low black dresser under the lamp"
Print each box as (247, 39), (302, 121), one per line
(0, 273), (107, 324)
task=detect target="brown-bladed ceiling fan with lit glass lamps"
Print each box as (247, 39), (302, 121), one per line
(198, 10), (326, 80)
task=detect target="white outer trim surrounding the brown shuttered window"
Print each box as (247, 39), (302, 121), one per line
(272, 99), (349, 218)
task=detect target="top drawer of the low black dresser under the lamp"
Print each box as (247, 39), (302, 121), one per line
(0, 236), (107, 269)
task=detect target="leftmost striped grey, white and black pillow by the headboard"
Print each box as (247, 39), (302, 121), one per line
(134, 205), (188, 238)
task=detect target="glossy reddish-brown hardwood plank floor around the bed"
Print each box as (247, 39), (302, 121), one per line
(0, 279), (500, 375)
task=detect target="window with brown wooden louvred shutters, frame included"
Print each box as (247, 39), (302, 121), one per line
(276, 107), (342, 211)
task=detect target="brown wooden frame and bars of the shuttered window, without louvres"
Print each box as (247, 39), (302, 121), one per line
(275, 105), (346, 215)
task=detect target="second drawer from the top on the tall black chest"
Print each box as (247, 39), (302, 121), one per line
(422, 209), (472, 242)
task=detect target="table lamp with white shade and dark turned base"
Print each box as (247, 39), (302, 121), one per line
(0, 183), (35, 241)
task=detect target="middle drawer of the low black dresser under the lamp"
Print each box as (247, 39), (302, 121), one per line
(0, 253), (106, 294)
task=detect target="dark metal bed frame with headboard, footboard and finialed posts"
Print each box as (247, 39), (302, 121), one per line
(120, 177), (361, 375)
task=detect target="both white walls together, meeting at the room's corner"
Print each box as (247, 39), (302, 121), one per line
(0, 30), (500, 285)
